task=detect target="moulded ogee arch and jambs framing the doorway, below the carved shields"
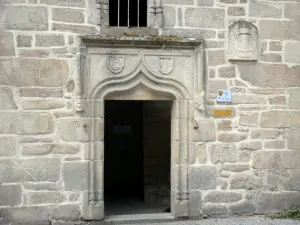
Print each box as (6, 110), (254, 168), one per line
(77, 36), (201, 220)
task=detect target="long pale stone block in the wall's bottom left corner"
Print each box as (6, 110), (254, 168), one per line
(0, 206), (49, 225)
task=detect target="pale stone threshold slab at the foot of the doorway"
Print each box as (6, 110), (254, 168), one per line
(103, 213), (175, 223)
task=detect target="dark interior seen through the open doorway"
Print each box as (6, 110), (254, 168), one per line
(104, 100), (172, 216)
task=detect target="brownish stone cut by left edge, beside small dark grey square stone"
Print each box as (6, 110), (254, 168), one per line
(0, 31), (15, 56)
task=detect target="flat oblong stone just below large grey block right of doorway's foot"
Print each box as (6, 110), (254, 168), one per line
(203, 191), (243, 203)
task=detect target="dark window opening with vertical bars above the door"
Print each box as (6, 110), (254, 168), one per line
(109, 0), (147, 27)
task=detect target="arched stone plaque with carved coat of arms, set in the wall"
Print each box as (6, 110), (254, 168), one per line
(228, 21), (259, 60)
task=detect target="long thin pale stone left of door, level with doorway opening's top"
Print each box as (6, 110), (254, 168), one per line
(21, 99), (65, 110)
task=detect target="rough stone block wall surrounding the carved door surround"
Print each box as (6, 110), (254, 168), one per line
(0, 0), (300, 222)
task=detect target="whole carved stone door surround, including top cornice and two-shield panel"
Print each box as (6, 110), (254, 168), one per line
(77, 36), (204, 220)
